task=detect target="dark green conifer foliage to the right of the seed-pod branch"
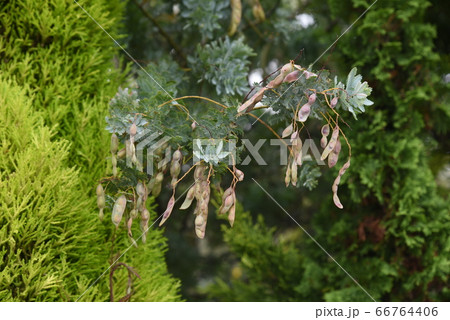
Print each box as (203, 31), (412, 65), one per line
(206, 0), (450, 301)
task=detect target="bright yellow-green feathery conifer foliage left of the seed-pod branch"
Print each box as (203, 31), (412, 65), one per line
(0, 0), (183, 301)
